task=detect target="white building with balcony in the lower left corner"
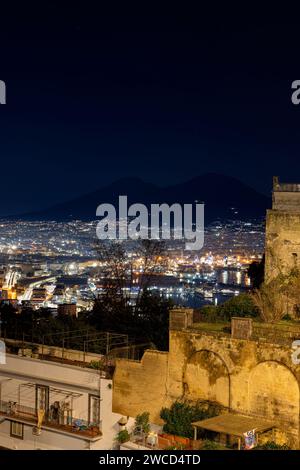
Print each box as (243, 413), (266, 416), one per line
(0, 354), (127, 450)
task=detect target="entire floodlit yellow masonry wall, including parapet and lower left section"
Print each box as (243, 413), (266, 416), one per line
(113, 309), (300, 448)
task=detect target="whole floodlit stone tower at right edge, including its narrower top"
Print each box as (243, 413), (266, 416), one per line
(265, 176), (300, 282)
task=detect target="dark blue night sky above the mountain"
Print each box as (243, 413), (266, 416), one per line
(0, 5), (300, 215)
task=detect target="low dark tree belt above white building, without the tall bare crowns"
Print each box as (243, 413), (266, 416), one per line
(0, 291), (172, 352)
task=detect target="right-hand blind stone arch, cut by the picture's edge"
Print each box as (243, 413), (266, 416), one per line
(248, 360), (299, 442)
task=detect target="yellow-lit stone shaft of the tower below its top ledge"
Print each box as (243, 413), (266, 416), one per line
(265, 207), (300, 282)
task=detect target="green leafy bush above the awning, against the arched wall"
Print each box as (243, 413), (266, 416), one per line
(160, 401), (221, 438)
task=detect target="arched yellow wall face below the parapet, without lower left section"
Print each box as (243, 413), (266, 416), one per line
(168, 330), (300, 447)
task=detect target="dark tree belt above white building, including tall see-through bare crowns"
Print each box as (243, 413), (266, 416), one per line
(0, 240), (172, 354)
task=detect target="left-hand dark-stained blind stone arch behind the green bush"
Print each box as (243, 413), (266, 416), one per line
(183, 349), (230, 408)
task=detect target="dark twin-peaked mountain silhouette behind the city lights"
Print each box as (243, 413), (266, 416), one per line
(3, 173), (271, 223)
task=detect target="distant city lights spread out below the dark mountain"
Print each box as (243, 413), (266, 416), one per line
(0, 220), (264, 312)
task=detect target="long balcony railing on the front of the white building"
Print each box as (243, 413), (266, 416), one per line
(0, 401), (102, 438)
